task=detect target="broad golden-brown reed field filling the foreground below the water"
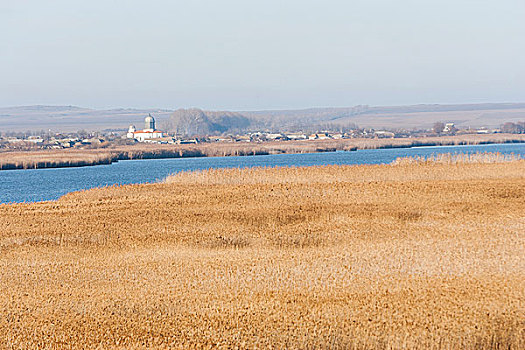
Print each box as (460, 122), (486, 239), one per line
(0, 155), (525, 349)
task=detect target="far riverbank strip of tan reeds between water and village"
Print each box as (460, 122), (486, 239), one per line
(0, 134), (525, 170)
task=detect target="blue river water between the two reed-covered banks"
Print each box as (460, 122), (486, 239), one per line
(0, 144), (525, 203)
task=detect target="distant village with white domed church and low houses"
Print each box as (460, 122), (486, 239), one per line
(0, 114), (525, 149)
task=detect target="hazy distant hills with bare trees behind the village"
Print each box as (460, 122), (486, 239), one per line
(0, 103), (525, 135)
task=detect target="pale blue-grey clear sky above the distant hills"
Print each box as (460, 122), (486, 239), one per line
(0, 0), (525, 110)
